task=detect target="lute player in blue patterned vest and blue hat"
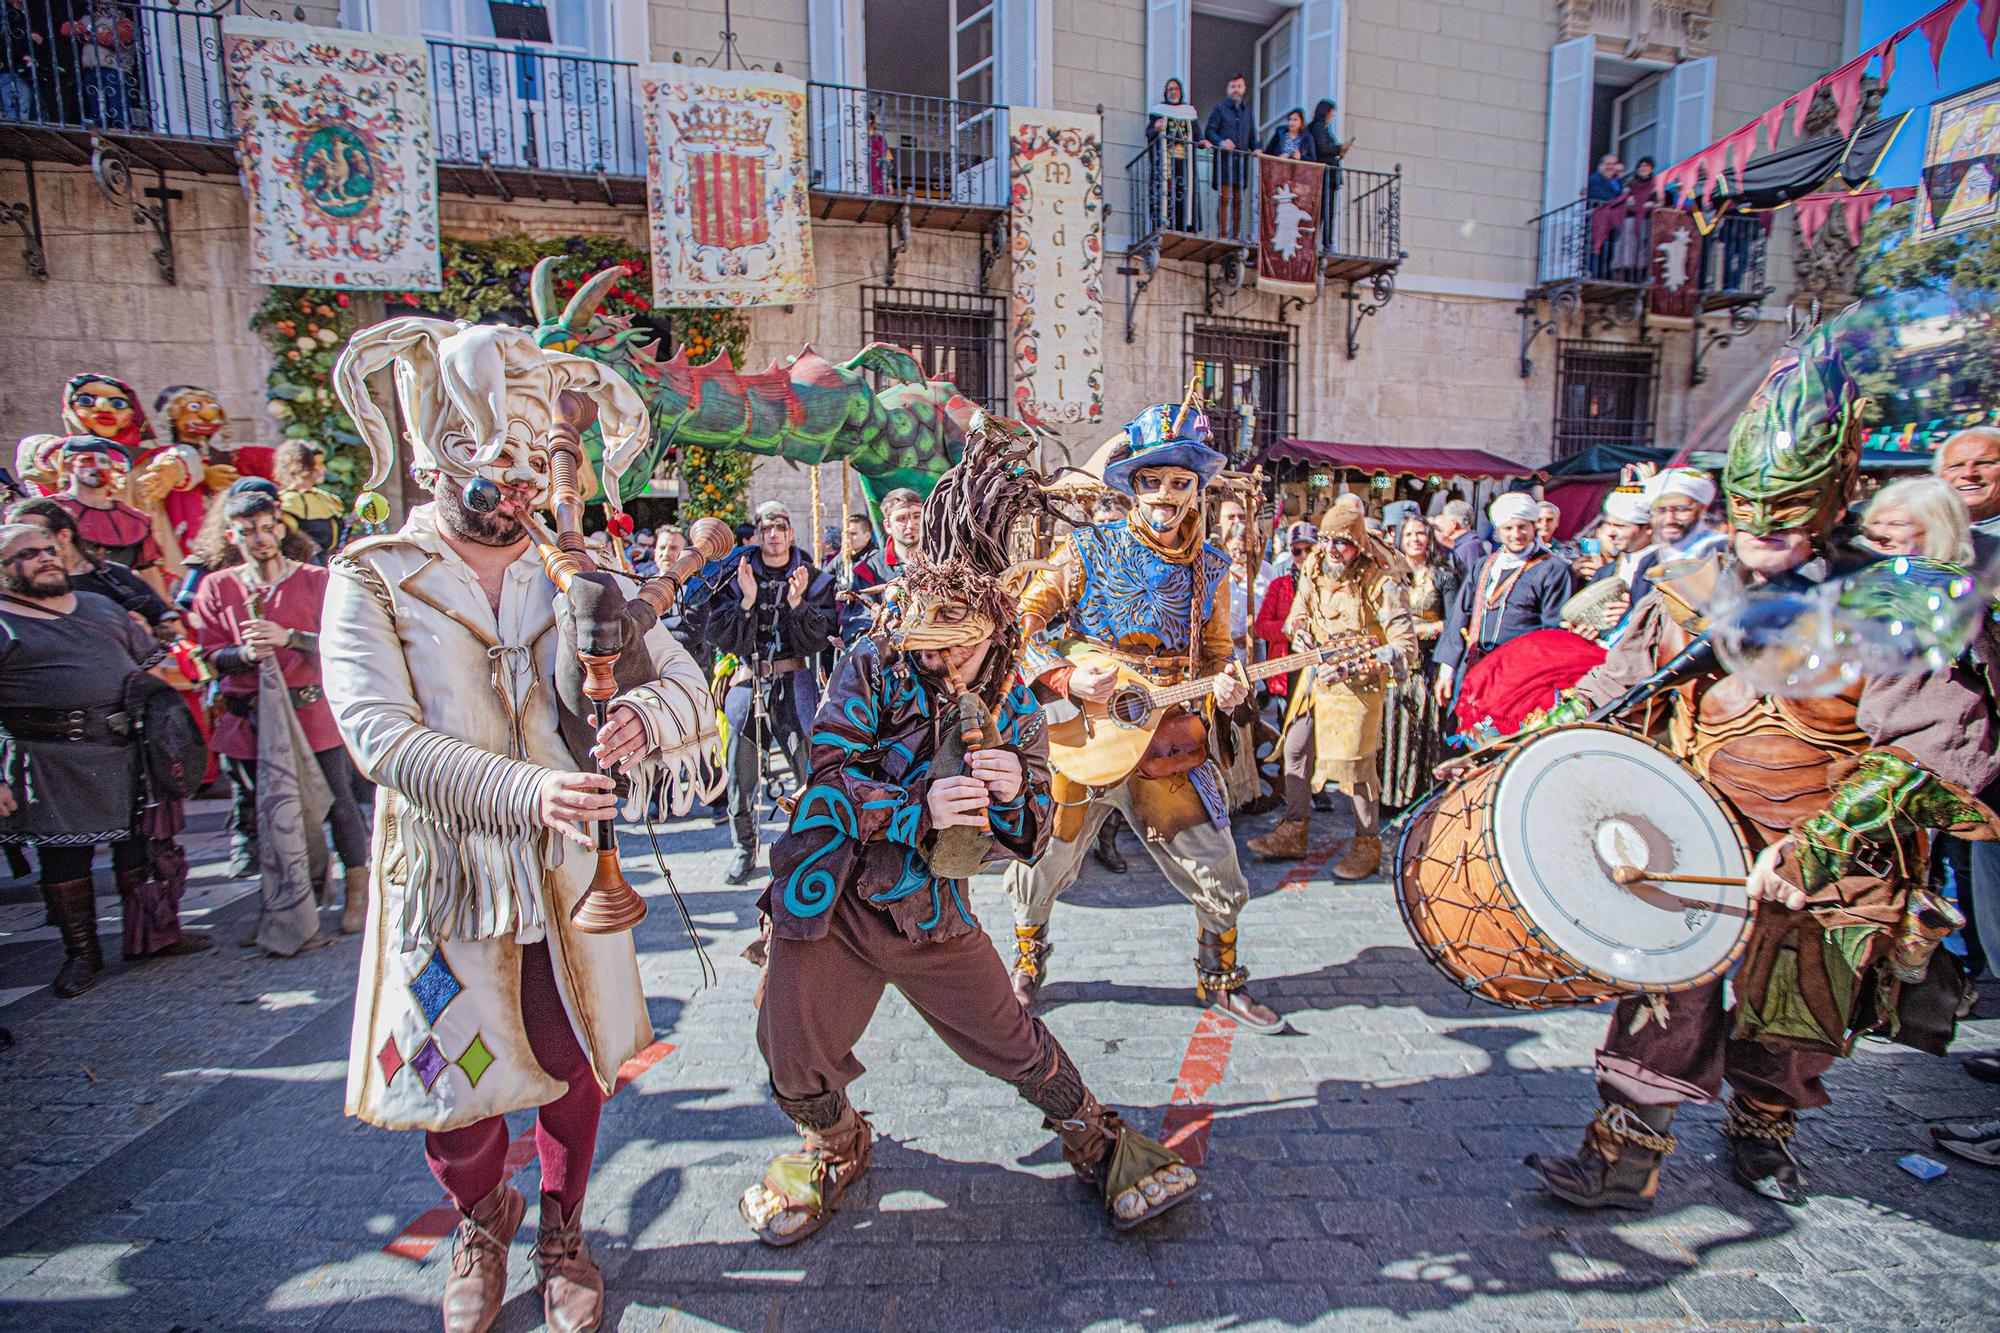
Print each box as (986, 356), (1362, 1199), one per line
(1006, 404), (1284, 1033)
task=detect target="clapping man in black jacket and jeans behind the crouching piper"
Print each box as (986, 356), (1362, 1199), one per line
(706, 500), (838, 885)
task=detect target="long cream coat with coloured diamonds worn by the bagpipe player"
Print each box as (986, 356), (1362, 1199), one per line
(332, 504), (716, 1129)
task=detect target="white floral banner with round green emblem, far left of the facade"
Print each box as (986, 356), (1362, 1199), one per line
(222, 18), (444, 292)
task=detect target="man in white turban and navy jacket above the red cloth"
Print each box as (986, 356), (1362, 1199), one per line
(1436, 490), (1570, 707)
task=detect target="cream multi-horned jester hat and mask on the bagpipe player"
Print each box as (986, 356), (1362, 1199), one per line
(334, 318), (652, 506)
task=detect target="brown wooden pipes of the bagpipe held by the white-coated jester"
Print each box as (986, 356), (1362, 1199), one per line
(528, 390), (736, 935)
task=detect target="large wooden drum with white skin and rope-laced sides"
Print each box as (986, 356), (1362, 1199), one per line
(1396, 725), (1750, 1009)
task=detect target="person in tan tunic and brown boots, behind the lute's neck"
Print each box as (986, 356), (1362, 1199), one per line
(1250, 504), (1418, 879)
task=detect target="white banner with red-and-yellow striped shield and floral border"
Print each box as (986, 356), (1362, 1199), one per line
(640, 64), (812, 308)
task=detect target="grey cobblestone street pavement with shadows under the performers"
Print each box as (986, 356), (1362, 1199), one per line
(0, 792), (2000, 1331)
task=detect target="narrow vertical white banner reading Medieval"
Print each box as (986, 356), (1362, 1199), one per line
(1008, 106), (1104, 426)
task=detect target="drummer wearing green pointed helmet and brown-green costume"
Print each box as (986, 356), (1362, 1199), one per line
(1528, 330), (2000, 1209)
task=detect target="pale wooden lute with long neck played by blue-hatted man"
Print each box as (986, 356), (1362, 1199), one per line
(1048, 630), (1386, 787)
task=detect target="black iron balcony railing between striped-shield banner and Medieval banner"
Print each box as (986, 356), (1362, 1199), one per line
(806, 84), (1008, 210)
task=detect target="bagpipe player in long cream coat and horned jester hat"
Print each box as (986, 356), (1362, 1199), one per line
(332, 318), (716, 1333)
